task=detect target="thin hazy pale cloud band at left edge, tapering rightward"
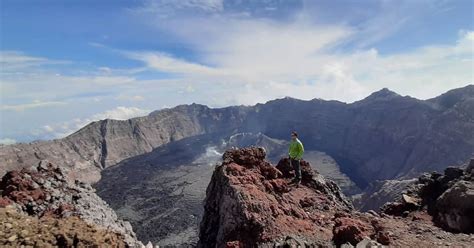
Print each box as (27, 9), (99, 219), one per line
(0, 55), (137, 103)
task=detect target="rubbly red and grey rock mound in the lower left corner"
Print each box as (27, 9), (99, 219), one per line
(0, 160), (142, 247)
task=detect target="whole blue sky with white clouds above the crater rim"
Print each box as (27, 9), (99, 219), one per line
(0, 0), (474, 144)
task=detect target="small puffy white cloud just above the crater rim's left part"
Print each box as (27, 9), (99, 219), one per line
(39, 106), (151, 139)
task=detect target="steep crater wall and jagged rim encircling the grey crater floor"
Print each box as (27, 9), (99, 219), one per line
(0, 85), (474, 187)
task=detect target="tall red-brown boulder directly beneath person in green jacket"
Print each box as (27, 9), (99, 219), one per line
(198, 148), (351, 247)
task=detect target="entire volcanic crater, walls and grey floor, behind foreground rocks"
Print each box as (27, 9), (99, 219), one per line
(0, 85), (474, 245)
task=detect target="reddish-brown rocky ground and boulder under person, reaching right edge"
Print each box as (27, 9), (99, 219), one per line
(198, 147), (474, 247)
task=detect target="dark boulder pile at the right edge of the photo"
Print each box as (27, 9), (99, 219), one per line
(382, 159), (474, 233)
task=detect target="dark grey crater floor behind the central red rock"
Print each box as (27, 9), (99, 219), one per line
(94, 133), (354, 247)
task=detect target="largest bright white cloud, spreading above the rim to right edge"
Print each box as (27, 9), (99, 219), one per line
(125, 9), (474, 106)
